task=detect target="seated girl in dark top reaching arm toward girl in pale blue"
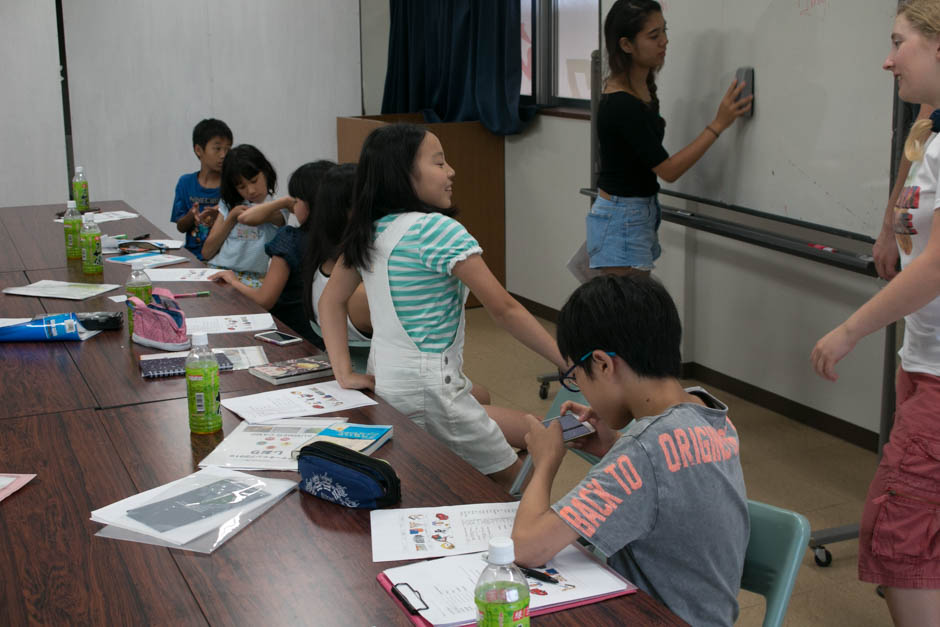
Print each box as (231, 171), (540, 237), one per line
(210, 160), (334, 343)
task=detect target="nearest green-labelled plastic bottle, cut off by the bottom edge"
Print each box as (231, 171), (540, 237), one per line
(473, 538), (529, 627)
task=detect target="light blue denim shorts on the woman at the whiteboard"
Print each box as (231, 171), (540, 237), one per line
(587, 196), (662, 270)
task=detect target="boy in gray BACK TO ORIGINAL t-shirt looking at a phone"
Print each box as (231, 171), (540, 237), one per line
(512, 276), (749, 625)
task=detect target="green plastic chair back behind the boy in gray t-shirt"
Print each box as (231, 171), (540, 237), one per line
(741, 500), (810, 627)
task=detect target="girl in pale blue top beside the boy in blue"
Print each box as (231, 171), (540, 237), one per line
(202, 144), (293, 287)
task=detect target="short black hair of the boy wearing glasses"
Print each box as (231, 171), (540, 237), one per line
(557, 275), (682, 379)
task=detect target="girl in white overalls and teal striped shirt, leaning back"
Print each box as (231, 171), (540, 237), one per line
(318, 124), (565, 486)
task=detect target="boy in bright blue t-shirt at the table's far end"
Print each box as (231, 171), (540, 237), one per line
(170, 118), (232, 261)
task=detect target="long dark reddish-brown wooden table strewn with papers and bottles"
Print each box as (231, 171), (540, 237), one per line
(0, 203), (683, 625)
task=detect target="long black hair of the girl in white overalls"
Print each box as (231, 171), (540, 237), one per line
(340, 124), (457, 268)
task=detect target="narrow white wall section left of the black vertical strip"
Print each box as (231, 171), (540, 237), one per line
(0, 0), (69, 206)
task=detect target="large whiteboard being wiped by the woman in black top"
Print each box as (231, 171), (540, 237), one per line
(657, 0), (897, 235)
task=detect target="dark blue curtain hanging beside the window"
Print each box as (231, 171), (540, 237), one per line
(382, 0), (535, 135)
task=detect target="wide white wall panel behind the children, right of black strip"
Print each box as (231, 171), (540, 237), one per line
(63, 0), (361, 233)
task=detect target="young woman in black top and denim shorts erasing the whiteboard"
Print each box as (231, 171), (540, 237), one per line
(600, 0), (753, 274)
